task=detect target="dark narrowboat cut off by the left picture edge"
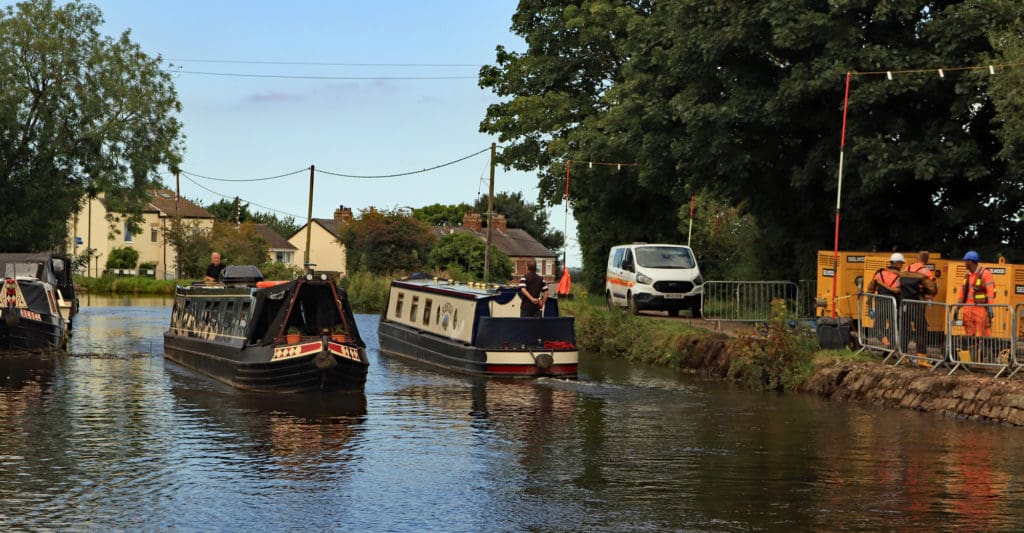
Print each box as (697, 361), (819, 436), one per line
(0, 254), (78, 352)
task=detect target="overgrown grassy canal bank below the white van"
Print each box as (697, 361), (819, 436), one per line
(559, 294), (871, 390)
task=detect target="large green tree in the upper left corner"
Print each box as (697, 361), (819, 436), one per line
(0, 0), (182, 251)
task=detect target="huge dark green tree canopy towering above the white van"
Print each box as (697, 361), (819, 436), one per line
(479, 0), (1024, 285)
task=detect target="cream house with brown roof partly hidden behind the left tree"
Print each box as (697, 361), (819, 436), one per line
(68, 189), (214, 279)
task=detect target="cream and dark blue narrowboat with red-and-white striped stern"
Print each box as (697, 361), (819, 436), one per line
(377, 278), (580, 377)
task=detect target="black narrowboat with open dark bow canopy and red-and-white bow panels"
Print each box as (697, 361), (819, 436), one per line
(164, 265), (369, 392)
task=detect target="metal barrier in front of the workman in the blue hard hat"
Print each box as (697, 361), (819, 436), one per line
(949, 304), (1016, 377)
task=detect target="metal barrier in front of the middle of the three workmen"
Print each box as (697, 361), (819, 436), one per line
(896, 300), (950, 370)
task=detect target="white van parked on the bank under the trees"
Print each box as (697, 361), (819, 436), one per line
(604, 242), (703, 317)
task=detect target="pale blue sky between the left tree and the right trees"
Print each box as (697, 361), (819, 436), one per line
(73, 0), (581, 266)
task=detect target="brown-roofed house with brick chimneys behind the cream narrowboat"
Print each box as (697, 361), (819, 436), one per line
(433, 212), (558, 282)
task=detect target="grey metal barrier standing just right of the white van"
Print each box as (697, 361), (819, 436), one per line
(700, 281), (800, 322)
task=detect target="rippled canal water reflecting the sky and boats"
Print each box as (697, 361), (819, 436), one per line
(0, 297), (1024, 532)
